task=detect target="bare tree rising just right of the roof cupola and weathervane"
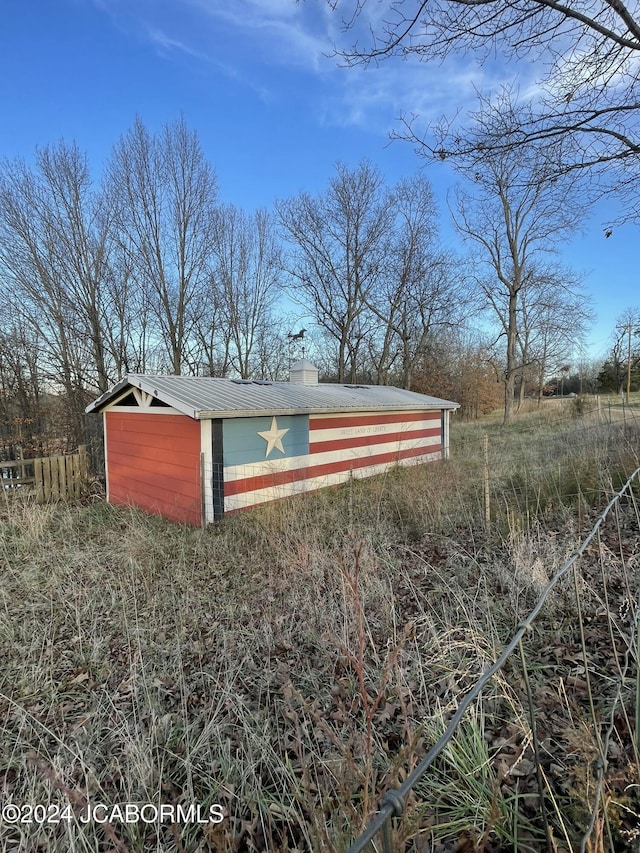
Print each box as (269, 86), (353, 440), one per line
(277, 161), (390, 382)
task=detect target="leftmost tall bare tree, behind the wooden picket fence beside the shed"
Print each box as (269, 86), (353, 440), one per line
(0, 143), (112, 442)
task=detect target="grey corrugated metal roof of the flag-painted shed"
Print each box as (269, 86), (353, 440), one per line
(86, 374), (458, 419)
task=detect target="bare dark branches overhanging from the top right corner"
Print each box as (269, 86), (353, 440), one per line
(328, 0), (640, 216)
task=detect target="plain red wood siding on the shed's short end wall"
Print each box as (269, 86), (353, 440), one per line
(106, 411), (202, 525)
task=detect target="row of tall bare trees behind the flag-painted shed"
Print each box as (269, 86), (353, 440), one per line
(0, 119), (587, 460)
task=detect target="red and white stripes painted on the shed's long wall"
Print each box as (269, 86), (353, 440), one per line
(224, 411), (442, 512)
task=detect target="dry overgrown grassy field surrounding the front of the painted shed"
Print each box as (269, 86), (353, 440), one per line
(0, 404), (640, 853)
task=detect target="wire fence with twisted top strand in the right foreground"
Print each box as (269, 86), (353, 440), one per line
(349, 468), (640, 853)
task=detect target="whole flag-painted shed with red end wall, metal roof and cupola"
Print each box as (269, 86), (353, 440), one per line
(87, 359), (458, 525)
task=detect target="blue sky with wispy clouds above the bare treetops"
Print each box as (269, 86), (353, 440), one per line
(0, 0), (640, 356)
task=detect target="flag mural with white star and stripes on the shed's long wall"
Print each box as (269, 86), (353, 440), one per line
(223, 411), (443, 512)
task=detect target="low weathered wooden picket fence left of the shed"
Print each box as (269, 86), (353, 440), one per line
(0, 445), (87, 503)
